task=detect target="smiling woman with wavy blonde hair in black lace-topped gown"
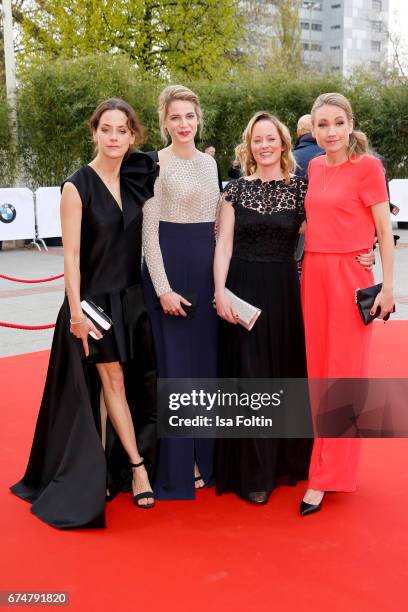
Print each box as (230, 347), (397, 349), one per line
(214, 112), (312, 504)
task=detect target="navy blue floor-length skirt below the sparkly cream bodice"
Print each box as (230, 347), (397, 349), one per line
(143, 221), (217, 499)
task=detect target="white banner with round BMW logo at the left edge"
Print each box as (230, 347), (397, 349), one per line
(0, 187), (35, 240)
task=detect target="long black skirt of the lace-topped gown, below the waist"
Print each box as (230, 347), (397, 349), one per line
(215, 258), (313, 499)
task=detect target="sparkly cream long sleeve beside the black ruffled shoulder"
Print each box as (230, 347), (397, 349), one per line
(142, 178), (172, 297)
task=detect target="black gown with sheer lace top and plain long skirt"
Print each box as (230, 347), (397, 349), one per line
(216, 177), (312, 499)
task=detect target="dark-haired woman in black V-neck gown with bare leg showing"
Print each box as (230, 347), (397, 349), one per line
(12, 99), (156, 528)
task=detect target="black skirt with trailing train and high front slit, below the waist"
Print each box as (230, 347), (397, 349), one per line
(11, 285), (157, 529)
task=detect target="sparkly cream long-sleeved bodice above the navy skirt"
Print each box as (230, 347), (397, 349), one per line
(143, 151), (220, 296)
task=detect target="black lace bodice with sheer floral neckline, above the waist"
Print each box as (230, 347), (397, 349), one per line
(223, 177), (307, 262)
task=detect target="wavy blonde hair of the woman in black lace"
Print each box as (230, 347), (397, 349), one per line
(235, 111), (296, 185)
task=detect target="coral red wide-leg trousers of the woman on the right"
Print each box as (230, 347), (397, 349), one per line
(302, 251), (373, 491)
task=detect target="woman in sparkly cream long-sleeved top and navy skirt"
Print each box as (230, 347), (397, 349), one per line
(143, 86), (220, 499)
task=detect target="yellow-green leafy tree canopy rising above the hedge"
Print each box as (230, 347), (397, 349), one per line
(15, 0), (244, 78)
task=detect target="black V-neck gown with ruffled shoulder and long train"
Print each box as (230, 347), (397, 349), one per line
(11, 152), (157, 529)
